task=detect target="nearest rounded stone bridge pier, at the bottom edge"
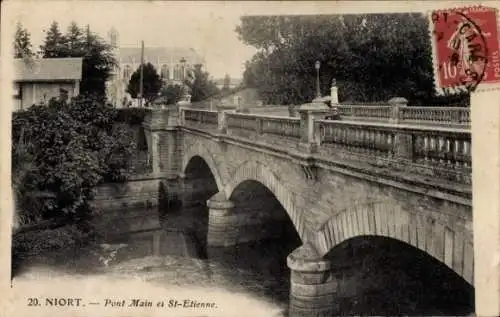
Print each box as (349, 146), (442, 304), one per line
(287, 244), (339, 317)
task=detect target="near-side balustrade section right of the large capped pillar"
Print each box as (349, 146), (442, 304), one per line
(315, 120), (472, 184)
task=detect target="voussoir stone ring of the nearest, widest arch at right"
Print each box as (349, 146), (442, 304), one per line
(316, 202), (474, 285)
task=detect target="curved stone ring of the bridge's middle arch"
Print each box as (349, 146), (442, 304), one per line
(225, 160), (306, 241)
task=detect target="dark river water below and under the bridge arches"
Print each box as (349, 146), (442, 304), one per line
(10, 200), (474, 317)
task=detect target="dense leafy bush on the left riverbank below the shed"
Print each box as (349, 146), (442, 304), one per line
(12, 96), (136, 220)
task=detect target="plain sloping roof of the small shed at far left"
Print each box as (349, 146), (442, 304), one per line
(14, 57), (83, 81)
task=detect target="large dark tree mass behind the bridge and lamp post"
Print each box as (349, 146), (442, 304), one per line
(236, 14), (468, 104)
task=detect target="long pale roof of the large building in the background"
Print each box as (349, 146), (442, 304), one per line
(118, 47), (205, 65)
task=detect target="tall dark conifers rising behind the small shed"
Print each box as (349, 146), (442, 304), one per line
(40, 21), (116, 96)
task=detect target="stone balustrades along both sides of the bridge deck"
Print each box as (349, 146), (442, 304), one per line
(181, 106), (471, 184)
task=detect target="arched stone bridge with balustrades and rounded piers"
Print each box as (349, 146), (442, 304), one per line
(144, 99), (474, 317)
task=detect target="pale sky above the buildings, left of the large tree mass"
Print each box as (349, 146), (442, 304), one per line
(5, 1), (264, 78)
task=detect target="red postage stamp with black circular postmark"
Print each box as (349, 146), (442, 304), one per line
(429, 6), (500, 94)
